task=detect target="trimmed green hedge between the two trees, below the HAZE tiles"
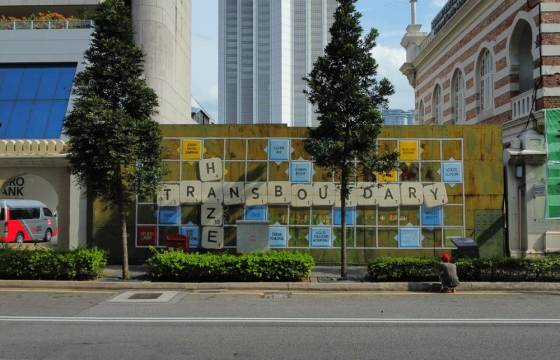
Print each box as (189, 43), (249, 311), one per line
(146, 248), (315, 282)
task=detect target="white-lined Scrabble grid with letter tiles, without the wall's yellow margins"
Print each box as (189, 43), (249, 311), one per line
(136, 138), (465, 249)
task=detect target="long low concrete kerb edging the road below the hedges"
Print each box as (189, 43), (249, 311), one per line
(0, 280), (560, 292)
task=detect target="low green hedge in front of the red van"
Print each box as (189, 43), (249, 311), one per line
(0, 244), (107, 280)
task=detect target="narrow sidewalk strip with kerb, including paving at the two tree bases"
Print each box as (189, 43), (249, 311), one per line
(0, 264), (560, 293)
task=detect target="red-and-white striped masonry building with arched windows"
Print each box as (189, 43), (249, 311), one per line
(400, 0), (560, 257)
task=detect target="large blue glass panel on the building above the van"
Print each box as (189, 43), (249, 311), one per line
(0, 63), (77, 139)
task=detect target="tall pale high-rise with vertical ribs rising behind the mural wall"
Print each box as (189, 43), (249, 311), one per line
(218, 0), (338, 126)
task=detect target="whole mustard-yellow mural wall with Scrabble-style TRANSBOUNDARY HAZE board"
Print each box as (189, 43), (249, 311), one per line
(93, 125), (504, 263)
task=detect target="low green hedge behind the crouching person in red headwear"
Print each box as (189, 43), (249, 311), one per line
(368, 257), (560, 282)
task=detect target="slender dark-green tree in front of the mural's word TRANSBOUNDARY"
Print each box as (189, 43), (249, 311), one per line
(304, 0), (398, 279)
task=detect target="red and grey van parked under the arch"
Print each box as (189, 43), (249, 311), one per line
(0, 199), (58, 243)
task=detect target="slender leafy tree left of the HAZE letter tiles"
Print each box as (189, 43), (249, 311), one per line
(63, 0), (167, 280)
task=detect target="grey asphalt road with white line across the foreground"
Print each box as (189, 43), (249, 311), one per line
(0, 289), (560, 359)
